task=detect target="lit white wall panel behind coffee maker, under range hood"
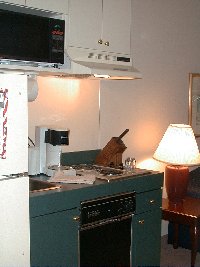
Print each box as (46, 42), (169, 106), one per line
(29, 77), (99, 152)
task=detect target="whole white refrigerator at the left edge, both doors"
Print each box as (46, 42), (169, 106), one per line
(0, 74), (30, 267)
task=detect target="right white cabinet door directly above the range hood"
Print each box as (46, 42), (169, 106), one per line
(102, 0), (131, 54)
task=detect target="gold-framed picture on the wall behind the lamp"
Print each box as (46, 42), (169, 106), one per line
(189, 73), (200, 137)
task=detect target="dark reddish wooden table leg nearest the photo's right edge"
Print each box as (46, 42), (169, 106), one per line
(190, 225), (199, 267)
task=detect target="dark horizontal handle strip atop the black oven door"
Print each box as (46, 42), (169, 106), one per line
(80, 213), (133, 230)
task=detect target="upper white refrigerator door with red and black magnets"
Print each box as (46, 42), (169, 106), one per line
(0, 74), (28, 177)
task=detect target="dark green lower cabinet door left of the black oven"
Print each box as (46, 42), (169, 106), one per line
(30, 209), (78, 267)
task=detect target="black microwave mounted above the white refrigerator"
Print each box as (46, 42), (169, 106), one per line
(0, 10), (65, 66)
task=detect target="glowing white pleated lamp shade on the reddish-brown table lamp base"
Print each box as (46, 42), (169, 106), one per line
(153, 124), (200, 166)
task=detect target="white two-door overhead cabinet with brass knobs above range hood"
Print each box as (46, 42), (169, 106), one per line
(68, 0), (131, 54)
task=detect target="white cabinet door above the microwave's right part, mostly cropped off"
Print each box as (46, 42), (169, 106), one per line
(26, 0), (68, 14)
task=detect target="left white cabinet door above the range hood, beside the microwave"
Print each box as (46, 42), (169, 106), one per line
(67, 0), (102, 49)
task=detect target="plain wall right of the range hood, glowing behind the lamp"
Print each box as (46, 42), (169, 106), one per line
(101, 0), (200, 166)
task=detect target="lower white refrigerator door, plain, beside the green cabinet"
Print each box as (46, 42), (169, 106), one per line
(0, 177), (30, 267)
